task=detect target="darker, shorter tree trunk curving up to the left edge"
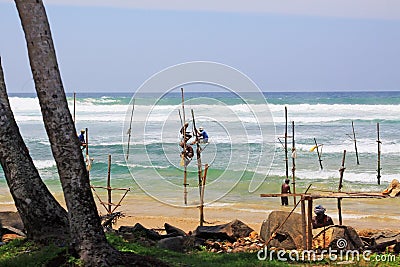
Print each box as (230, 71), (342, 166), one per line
(0, 58), (69, 241)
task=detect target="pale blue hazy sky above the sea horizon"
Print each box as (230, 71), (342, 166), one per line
(0, 0), (400, 93)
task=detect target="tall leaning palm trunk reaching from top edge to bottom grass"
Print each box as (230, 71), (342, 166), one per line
(15, 0), (119, 266)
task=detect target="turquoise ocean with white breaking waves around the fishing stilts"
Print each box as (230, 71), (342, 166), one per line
(0, 91), (400, 225)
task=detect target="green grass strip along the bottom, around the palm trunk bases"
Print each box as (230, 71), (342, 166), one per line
(0, 235), (400, 267)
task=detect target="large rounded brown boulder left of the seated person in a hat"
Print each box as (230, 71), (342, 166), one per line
(260, 211), (303, 249)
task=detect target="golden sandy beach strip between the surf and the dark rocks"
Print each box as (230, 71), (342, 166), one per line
(0, 188), (400, 236)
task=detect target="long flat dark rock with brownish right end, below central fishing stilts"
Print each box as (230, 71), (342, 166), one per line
(194, 220), (253, 242)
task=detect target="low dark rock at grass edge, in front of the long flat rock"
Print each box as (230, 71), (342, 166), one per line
(157, 236), (204, 252)
